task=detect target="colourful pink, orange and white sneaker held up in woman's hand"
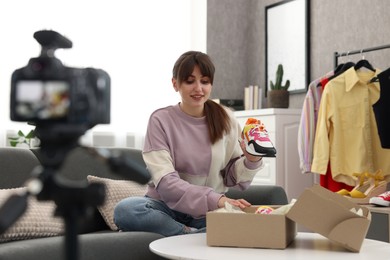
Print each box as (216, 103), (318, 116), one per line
(242, 118), (276, 157)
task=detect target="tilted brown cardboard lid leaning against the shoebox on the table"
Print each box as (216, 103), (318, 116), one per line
(287, 185), (371, 252)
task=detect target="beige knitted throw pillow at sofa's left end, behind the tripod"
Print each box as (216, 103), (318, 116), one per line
(0, 188), (65, 243)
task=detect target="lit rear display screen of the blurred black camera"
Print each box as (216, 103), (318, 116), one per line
(15, 80), (70, 120)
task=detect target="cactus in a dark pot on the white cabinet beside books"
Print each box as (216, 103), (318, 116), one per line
(268, 64), (290, 108)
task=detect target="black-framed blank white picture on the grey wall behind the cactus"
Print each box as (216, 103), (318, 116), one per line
(265, 0), (310, 94)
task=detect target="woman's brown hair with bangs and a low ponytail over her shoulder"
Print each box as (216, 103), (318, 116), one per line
(173, 51), (231, 144)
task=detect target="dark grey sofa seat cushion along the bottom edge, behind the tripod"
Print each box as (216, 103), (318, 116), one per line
(0, 231), (166, 260)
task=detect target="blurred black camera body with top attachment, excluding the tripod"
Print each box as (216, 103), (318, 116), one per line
(10, 30), (110, 129)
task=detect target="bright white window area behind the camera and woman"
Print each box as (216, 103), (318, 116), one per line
(0, 0), (206, 147)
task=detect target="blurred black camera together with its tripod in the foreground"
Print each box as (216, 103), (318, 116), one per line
(0, 30), (150, 260)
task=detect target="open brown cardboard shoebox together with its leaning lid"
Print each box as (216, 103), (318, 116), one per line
(206, 185), (371, 252)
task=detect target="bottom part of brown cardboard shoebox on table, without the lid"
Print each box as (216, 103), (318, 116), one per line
(206, 206), (297, 249)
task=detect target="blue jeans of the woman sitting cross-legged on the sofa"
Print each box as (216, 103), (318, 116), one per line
(114, 197), (206, 236)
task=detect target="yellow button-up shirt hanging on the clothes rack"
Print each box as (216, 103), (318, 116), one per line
(311, 67), (390, 186)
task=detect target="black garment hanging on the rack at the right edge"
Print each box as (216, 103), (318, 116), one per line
(373, 68), (390, 149)
